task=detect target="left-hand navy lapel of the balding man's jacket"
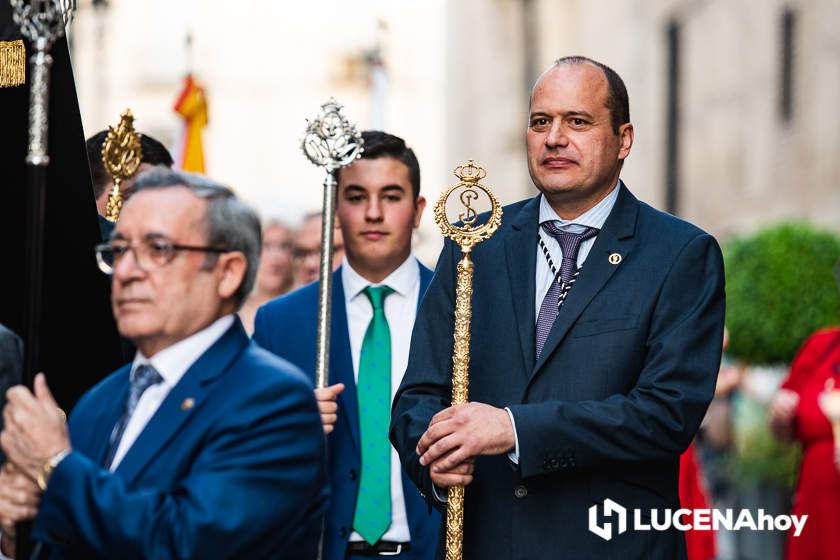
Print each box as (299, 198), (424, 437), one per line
(503, 196), (540, 371)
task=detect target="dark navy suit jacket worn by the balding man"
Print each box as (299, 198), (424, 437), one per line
(391, 185), (724, 560)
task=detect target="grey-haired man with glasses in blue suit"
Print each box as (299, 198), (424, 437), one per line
(0, 168), (327, 560)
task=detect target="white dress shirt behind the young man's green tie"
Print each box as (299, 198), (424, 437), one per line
(341, 255), (420, 542)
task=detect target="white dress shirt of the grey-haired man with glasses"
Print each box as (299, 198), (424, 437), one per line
(109, 315), (233, 472)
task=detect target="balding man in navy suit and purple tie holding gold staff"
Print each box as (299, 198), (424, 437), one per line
(391, 57), (724, 560)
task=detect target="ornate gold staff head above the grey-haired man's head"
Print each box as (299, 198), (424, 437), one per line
(102, 109), (142, 222)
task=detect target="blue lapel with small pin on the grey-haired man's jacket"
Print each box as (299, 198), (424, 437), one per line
(116, 319), (250, 481)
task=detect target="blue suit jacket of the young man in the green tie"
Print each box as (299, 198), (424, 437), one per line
(254, 265), (440, 560)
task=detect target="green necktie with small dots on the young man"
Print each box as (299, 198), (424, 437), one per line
(353, 286), (394, 544)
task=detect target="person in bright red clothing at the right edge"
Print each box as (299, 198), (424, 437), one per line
(770, 327), (840, 560)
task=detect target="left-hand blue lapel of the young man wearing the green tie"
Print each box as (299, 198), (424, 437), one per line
(330, 274), (359, 450)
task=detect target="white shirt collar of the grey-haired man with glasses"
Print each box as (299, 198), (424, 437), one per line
(131, 315), (234, 386)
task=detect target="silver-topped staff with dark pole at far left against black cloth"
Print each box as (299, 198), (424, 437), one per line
(9, 0), (76, 558)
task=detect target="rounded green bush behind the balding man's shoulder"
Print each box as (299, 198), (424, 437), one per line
(724, 223), (840, 365)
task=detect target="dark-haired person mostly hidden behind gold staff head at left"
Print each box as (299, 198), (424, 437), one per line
(85, 130), (174, 241)
